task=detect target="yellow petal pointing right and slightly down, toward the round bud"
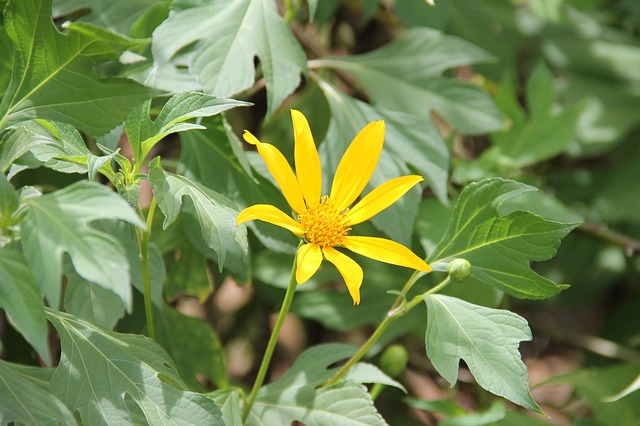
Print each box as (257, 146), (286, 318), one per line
(343, 236), (431, 272)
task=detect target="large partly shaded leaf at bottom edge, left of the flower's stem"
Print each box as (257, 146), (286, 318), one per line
(47, 310), (223, 425)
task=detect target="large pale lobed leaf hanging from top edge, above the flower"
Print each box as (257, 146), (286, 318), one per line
(153, 0), (307, 115)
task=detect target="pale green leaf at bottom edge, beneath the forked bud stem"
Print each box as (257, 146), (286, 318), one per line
(247, 344), (386, 426)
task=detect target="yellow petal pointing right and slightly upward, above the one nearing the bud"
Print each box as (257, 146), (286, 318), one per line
(345, 175), (424, 225)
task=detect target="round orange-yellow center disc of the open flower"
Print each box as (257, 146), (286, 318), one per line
(298, 195), (351, 247)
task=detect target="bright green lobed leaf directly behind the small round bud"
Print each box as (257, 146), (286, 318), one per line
(428, 178), (578, 299)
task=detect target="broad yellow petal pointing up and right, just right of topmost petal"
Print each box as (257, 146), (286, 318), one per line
(330, 121), (384, 210)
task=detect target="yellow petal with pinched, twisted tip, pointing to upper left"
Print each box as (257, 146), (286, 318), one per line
(242, 130), (305, 213)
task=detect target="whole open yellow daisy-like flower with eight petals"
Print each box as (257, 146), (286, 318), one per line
(237, 110), (431, 305)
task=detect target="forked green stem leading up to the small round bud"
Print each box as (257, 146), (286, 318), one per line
(325, 272), (451, 386)
